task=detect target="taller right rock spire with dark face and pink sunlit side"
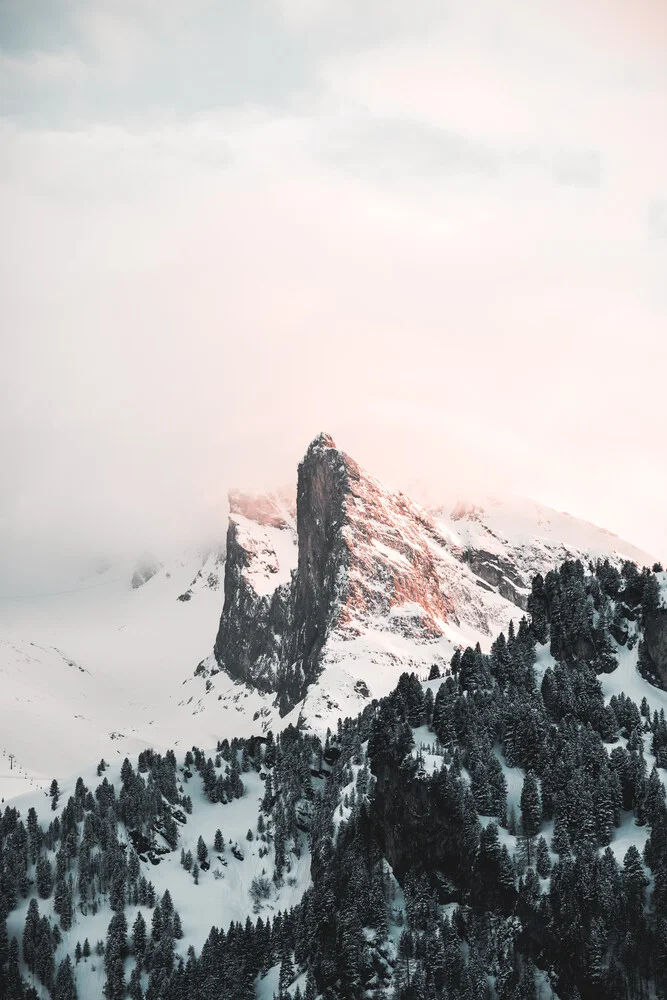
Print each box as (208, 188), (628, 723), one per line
(280, 435), (464, 707)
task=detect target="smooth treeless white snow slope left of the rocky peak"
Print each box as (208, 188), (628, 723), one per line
(0, 554), (257, 797)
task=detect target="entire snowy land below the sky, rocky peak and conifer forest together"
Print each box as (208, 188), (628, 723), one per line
(0, 434), (667, 1000)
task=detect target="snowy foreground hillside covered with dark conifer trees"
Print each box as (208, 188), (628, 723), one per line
(0, 561), (667, 1000)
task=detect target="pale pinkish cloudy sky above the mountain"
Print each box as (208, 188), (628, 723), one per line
(0, 0), (667, 592)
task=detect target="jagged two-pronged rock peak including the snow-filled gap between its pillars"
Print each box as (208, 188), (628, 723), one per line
(209, 434), (502, 713)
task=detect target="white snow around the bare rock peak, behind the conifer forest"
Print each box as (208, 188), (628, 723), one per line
(0, 477), (656, 798)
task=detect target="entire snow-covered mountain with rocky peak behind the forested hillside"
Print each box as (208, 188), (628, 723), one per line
(0, 435), (653, 795)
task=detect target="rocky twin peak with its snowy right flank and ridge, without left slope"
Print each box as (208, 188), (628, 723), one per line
(205, 434), (656, 728)
